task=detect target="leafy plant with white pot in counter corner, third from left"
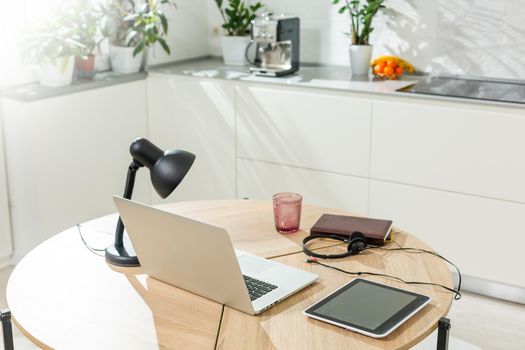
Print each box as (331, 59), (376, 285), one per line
(103, 0), (173, 73)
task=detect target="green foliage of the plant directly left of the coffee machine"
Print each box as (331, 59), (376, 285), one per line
(215, 0), (263, 36)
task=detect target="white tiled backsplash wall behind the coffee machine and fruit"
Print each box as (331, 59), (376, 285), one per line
(208, 0), (525, 80)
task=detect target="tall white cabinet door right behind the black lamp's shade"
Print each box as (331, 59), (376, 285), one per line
(147, 74), (235, 202)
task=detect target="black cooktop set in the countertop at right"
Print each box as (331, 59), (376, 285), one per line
(400, 77), (525, 104)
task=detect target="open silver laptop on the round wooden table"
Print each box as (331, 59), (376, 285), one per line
(113, 196), (318, 315)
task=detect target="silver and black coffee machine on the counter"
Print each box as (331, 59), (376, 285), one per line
(247, 13), (300, 77)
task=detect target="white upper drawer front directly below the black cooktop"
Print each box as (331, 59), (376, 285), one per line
(371, 99), (525, 203)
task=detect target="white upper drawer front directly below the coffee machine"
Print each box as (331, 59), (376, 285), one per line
(237, 85), (371, 176)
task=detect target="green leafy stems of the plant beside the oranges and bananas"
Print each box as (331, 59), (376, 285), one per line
(332, 0), (385, 45)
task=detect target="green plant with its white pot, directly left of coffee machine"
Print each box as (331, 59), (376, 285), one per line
(215, 0), (263, 66)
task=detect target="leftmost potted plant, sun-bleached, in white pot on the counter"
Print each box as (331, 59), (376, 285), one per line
(25, 12), (85, 86)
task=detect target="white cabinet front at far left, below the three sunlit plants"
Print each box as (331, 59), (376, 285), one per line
(3, 81), (150, 262)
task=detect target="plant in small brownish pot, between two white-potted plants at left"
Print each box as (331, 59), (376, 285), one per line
(71, 0), (104, 79)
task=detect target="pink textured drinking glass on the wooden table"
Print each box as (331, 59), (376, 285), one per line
(273, 192), (303, 233)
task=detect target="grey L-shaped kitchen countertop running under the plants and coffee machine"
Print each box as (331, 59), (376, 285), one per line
(0, 57), (524, 109)
